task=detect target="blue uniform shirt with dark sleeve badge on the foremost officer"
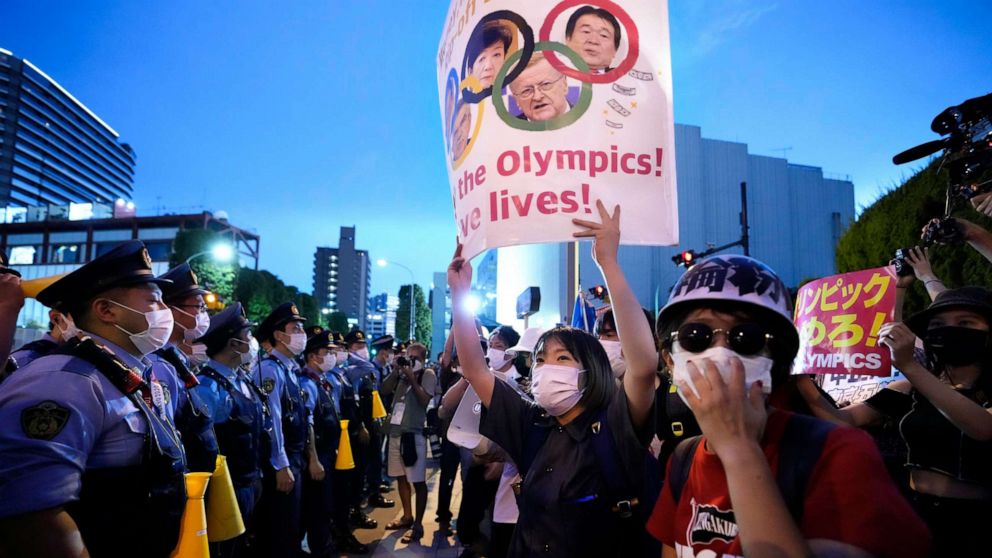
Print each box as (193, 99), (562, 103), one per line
(0, 334), (162, 517)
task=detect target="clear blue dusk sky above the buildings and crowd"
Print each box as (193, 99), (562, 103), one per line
(0, 0), (992, 300)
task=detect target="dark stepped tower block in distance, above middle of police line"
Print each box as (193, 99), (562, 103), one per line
(313, 227), (372, 330)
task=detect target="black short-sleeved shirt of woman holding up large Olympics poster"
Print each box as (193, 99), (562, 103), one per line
(479, 382), (654, 558)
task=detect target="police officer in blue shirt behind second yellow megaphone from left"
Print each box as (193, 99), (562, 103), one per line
(191, 302), (272, 558)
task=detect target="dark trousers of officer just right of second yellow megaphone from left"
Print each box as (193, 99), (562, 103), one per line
(255, 462), (303, 558)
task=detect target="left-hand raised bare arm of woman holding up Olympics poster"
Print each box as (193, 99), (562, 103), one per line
(448, 244), (496, 408)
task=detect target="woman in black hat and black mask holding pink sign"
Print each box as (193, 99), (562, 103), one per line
(800, 287), (992, 556)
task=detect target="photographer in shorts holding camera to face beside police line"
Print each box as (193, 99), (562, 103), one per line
(382, 343), (437, 544)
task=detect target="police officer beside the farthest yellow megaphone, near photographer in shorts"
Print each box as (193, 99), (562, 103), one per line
(344, 329), (381, 529)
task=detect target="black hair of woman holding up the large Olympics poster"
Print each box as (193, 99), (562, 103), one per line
(534, 326), (617, 410)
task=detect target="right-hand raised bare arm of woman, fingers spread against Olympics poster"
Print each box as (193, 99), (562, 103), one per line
(572, 200), (658, 427)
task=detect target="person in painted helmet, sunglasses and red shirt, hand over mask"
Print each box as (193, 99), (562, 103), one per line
(648, 255), (928, 558)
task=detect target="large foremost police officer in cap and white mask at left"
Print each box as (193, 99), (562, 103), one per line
(0, 240), (186, 557)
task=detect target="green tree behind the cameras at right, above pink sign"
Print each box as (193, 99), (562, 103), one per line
(837, 161), (992, 322)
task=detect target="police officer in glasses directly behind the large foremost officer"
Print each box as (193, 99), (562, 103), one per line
(148, 263), (217, 473)
